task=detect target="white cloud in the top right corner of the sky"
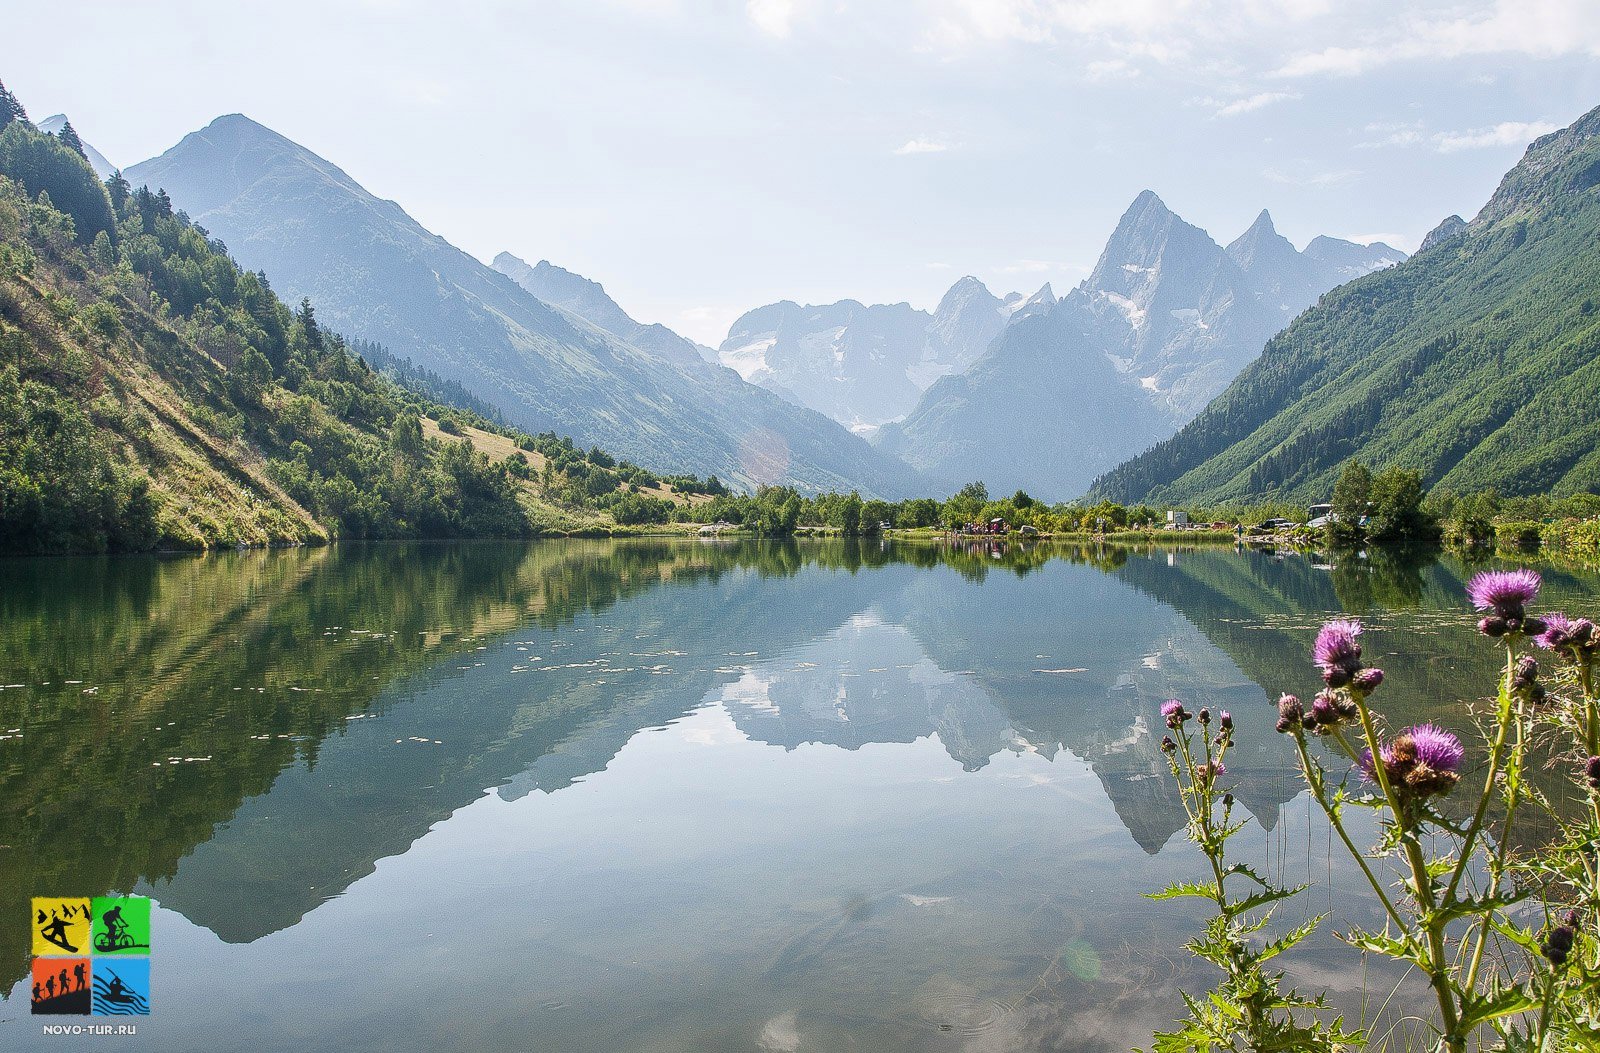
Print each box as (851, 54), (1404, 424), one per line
(1277, 0), (1600, 77)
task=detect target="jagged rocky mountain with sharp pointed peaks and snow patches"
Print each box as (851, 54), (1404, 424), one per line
(874, 190), (1405, 499)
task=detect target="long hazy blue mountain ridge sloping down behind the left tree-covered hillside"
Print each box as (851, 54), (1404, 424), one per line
(126, 114), (928, 498)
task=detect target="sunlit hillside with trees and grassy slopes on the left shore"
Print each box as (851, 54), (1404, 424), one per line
(0, 97), (707, 552)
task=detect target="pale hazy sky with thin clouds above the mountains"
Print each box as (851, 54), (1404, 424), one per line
(9, 0), (1600, 344)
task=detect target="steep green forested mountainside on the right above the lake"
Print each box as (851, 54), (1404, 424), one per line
(1093, 101), (1600, 502)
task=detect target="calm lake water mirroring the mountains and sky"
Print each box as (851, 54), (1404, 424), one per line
(0, 541), (1600, 1051)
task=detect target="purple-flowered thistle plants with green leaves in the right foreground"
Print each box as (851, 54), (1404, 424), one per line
(1155, 571), (1600, 1053)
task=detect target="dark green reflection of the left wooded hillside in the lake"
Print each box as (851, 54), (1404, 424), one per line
(0, 541), (819, 985)
